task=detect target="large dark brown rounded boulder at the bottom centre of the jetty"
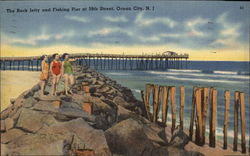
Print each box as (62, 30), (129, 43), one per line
(105, 119), (158, 156)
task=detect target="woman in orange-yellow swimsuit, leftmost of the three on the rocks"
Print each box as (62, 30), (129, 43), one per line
(40, 55), (49, 95)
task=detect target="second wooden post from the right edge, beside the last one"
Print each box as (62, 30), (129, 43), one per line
(233, 91), (239, 151)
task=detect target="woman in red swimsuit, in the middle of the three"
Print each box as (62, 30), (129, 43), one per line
(50, 53), (62, 96)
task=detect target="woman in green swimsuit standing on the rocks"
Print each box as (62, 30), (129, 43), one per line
(62, 53), (74, 95)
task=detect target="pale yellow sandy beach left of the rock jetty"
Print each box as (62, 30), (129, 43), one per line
(0, 71), (40, 111)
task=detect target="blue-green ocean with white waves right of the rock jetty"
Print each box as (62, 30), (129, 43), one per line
(99, 61), (250, 146)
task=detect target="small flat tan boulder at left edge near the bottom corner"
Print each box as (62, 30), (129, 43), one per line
(1, 128), (25, 144)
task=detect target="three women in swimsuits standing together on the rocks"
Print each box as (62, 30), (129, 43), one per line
(40, 53), (74, 96)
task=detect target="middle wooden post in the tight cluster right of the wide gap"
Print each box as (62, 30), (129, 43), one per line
(201, 88), (208, 145)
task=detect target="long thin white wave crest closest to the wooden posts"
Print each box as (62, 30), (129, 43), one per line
(162, 76), (243, 83)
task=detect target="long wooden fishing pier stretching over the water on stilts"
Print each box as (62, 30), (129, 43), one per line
(0, 53), (189, 71)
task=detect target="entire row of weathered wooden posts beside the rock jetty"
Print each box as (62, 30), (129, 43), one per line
(141, 84), (250, 153)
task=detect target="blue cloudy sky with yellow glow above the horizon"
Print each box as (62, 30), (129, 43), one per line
(0, 1), (250, 61)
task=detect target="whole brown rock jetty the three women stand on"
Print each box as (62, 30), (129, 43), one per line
(1, 66), (202, 156)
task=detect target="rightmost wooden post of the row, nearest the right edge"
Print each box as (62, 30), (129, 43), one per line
(240, 93), (246, 153)
